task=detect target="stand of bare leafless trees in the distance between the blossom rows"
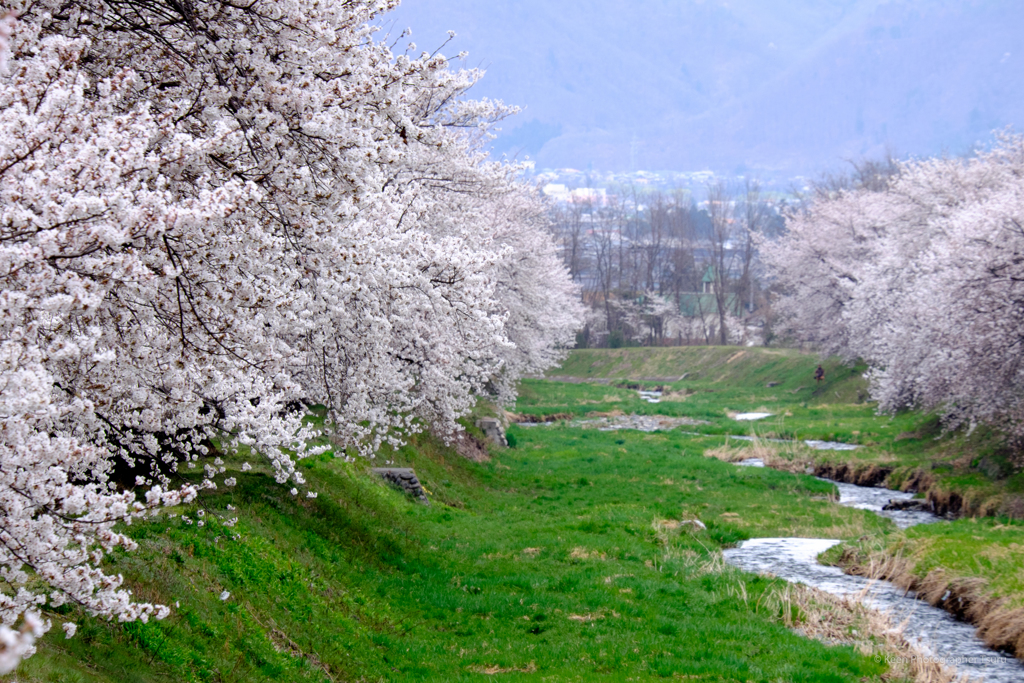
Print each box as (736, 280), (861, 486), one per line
(555, 180), (778, 344)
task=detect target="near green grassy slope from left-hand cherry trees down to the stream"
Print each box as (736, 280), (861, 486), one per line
(6, 430), (884, 681)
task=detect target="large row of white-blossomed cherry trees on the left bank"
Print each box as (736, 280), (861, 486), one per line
(0, 0), (580, 671)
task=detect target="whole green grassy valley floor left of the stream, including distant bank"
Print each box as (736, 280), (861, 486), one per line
(8, 348), (1024, 683)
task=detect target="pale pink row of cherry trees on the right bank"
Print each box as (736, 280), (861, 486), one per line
(761, 135), (1024, 436)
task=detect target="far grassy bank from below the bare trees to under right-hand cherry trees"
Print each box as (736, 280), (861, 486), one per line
(536, 347), (1024, 519)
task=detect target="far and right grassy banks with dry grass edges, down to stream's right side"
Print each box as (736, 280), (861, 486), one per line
(544, 347), (1024, 655)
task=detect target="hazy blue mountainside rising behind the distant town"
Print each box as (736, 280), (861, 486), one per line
(380, 0), (1024, 175)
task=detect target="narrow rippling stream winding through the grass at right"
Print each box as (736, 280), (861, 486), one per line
(722, 458), (1024, 683)
